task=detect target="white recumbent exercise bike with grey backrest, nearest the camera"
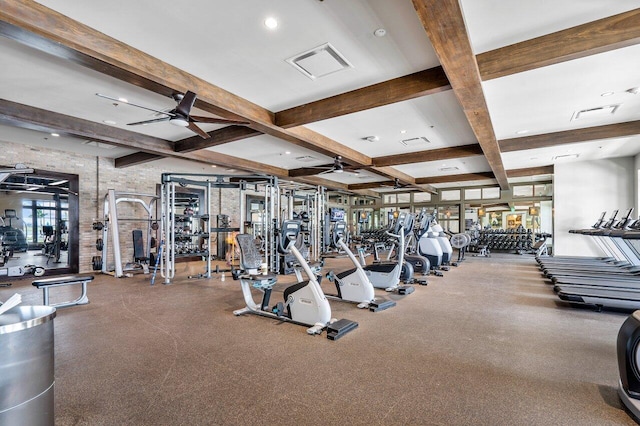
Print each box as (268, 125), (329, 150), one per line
(232, 221), (358, 340)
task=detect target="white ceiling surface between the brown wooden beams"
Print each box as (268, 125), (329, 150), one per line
(0, 0), (640, 195)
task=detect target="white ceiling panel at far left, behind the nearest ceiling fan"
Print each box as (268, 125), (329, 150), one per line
(0, 37), (228, 140)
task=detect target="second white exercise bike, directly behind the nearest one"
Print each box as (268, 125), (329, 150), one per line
(326, 221), (396, 312)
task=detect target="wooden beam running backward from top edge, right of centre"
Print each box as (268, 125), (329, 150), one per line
(412, 0), (509, 189)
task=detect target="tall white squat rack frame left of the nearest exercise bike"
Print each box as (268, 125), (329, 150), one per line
(159, 173), (280, 284)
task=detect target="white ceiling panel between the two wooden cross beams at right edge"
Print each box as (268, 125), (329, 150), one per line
(483, 46), (640, 139)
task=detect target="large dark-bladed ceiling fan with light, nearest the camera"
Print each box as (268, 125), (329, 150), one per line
(96, 91), (249, 139)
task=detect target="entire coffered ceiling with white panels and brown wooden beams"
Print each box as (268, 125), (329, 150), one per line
(0, 0), (640, 194)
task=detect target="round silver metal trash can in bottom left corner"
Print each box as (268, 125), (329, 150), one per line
(0, 306), (56, 426)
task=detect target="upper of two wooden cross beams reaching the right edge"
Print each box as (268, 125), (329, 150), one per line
(478, 9), (640, 80)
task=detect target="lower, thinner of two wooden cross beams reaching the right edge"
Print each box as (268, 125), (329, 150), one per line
(498, 120), (640, 152)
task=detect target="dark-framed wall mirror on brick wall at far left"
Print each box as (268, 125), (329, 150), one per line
(0, 165), (79, 279)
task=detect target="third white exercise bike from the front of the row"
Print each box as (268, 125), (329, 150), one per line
(362, 213), (415, 294)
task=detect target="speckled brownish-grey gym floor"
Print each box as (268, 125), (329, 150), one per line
(0, 254), (635, 426)
